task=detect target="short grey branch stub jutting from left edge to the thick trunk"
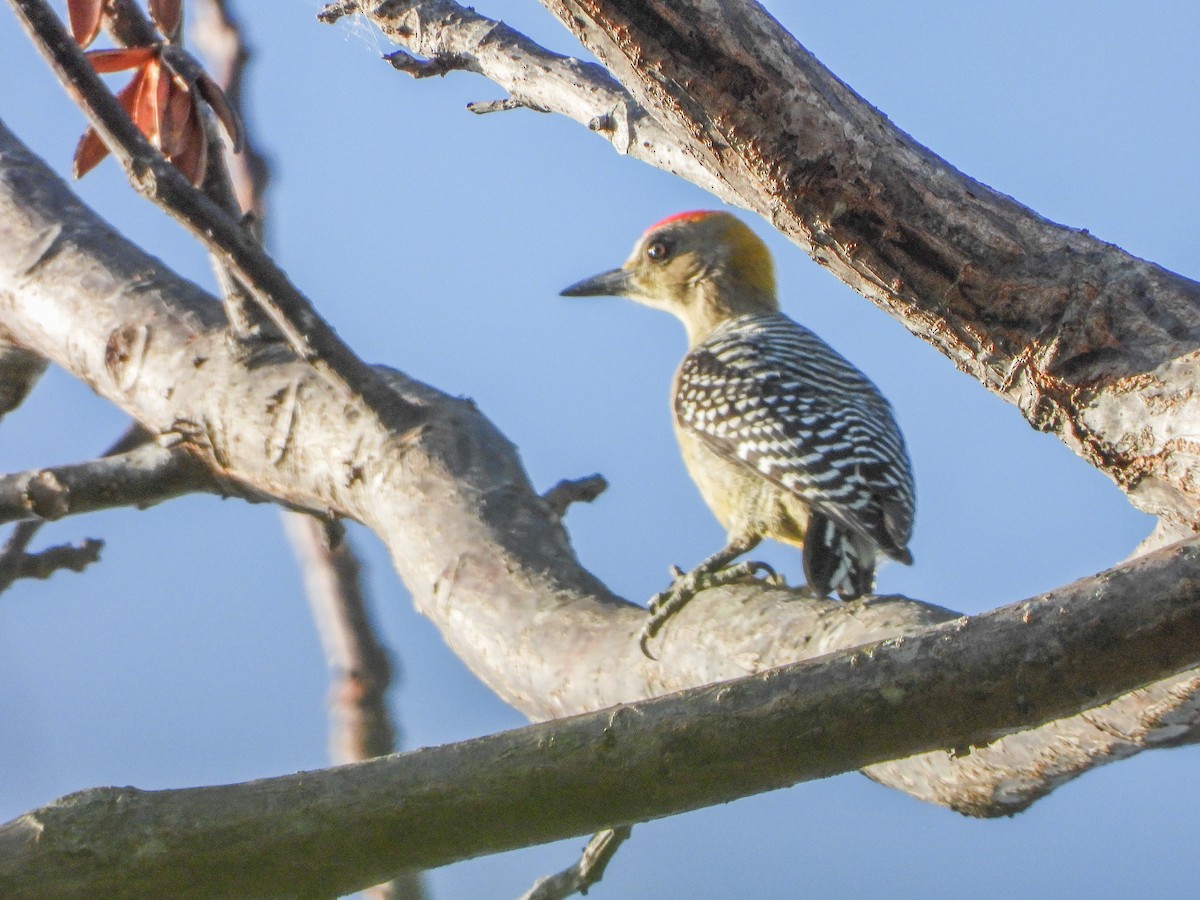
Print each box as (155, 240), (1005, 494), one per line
(0, 444), (219, 523)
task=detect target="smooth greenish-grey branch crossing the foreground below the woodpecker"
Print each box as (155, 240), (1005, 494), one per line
(7, 541), (1200, 898)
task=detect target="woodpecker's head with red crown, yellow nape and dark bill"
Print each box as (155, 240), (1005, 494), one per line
(562, 211), (779, 346)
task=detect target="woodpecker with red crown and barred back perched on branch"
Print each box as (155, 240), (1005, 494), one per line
(562, 211), (916, 655)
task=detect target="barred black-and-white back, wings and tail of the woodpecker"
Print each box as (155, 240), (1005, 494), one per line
(674, 313), (914, 598)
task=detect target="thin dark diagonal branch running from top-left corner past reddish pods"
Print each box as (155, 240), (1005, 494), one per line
(10, 0), (415, 427)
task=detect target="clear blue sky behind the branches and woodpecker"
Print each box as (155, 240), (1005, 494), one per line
(0, 0), (1200, 900)
